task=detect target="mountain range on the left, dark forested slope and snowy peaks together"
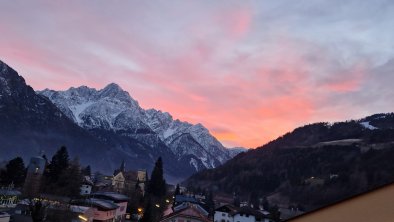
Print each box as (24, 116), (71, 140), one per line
(0, 61), (244, 180)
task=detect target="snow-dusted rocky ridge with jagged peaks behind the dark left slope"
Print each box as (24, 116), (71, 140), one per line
(38, 83), (237, 171)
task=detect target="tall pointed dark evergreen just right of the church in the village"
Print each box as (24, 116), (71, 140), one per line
(147, 157), (166, 197)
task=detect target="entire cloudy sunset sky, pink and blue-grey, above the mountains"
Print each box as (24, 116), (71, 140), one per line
(0, 0), (394, 148)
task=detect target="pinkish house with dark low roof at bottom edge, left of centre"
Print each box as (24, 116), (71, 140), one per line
(70, 198), (119, 222)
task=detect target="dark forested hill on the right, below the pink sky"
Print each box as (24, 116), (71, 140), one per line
(184, 113), (394, 215)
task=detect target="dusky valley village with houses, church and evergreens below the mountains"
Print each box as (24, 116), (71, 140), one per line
(0, 147), (279, 222)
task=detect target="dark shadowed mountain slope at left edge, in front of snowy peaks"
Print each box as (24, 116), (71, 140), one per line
(0, 61), (120, 172)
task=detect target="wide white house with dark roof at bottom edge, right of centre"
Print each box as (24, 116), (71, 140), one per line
(214, 205), (272, 222)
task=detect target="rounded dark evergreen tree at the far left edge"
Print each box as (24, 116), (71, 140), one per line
(1, 157), (26, 187)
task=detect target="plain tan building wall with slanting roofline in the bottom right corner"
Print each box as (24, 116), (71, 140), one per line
(286, 183), (394, 222)
